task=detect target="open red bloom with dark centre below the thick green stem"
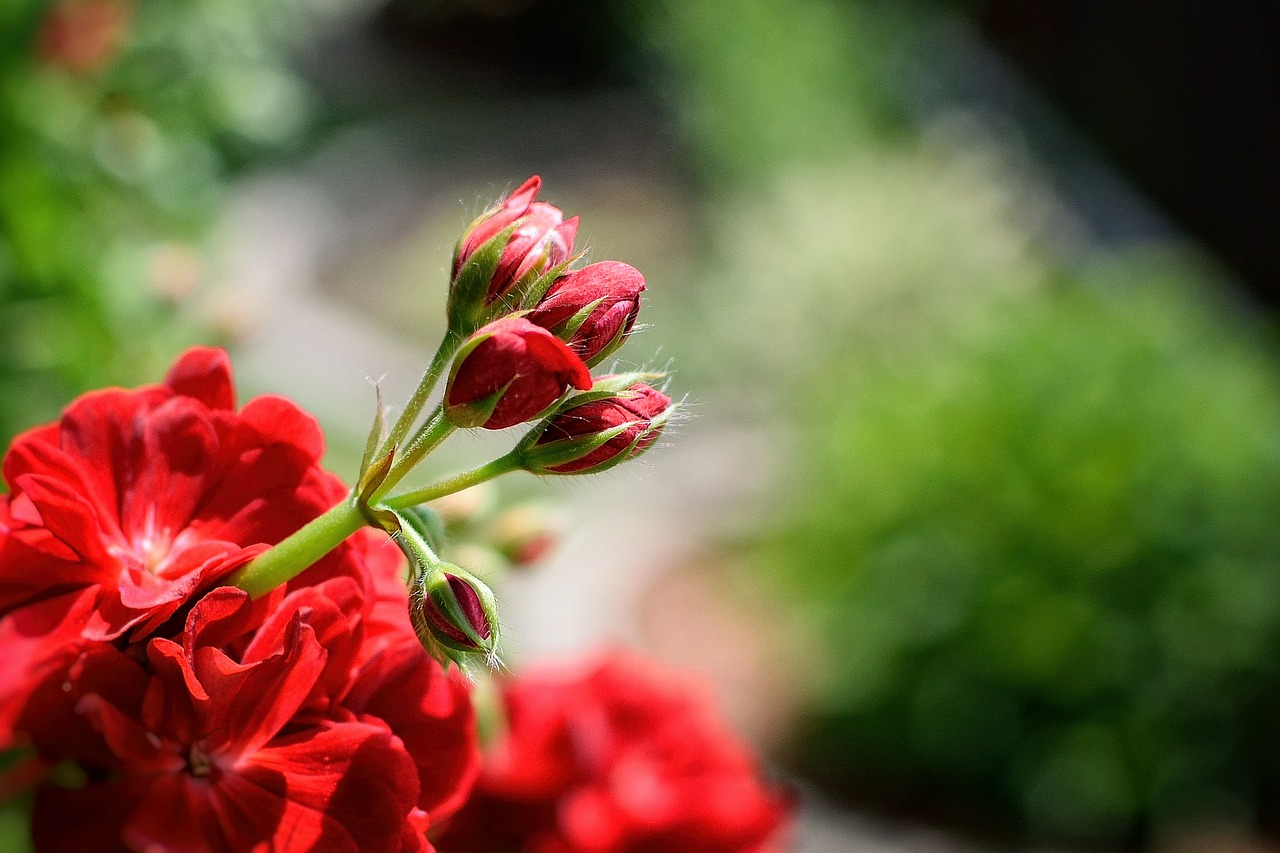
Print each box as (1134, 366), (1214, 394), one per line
(23, 550), (477, 852)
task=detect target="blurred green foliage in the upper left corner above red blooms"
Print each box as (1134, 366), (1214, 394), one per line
(0, 0), (325, 439)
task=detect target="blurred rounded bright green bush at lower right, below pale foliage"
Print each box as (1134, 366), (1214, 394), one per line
(756, 266), (1280, 840)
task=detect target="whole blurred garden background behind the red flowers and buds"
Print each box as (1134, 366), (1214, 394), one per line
(0, 0), (1280, 852)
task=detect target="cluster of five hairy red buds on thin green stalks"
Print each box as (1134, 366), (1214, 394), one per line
(340, 177), (676, 663)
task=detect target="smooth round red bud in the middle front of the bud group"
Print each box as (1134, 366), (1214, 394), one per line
(444, 316), (591, 429)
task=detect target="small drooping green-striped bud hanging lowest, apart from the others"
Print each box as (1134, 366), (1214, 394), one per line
(410, 566), (498, 654)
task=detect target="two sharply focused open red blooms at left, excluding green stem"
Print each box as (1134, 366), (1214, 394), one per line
(0, 350), (479, 850)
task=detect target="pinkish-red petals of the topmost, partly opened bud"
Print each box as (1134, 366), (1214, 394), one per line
(453, 175), (577, 305)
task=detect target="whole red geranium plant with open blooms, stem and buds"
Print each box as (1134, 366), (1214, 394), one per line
(0, 177), (787, 853)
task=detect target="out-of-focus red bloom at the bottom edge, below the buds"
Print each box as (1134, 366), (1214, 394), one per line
(436, 656), (788, 853)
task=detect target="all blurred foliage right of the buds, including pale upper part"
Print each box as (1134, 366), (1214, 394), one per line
(640, 0), (1280, 845)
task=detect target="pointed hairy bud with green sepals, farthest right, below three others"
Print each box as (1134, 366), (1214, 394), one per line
(525, 383), (673, 474)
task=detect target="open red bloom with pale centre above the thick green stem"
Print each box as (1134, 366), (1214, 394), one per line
(0, 348), (346, 639)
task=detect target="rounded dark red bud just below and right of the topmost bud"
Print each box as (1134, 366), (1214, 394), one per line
(526, 261), (644, 365)
